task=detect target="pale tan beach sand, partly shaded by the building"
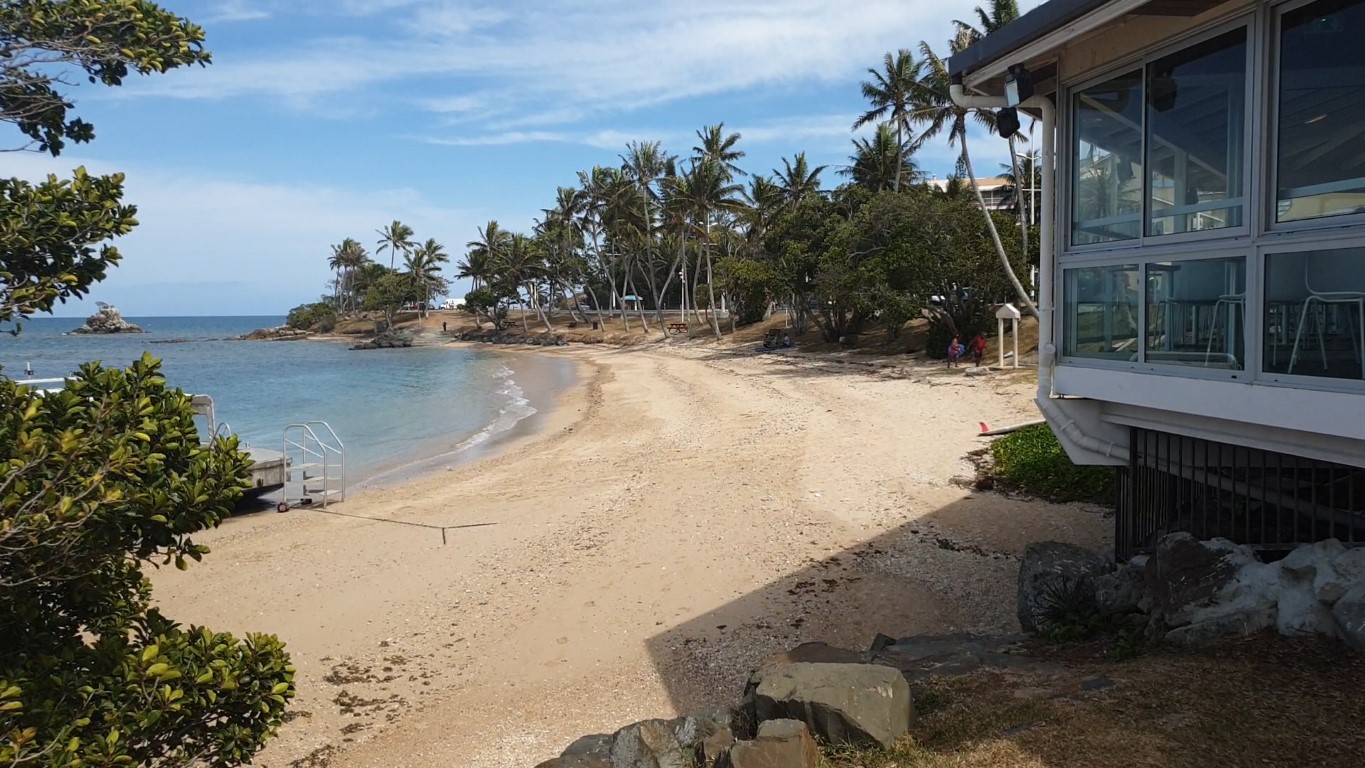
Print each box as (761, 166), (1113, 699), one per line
(153, 346), (1112, 768)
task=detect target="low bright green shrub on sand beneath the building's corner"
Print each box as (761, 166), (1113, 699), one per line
(991, 424), (1114, 503)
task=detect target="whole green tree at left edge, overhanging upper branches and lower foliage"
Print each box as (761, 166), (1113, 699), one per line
(0, 6), (293, 767)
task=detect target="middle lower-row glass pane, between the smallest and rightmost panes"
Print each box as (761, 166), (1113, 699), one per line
(1147, 256), (1246, 371)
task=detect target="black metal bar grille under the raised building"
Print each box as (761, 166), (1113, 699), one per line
(1114, 428), (1365, 559)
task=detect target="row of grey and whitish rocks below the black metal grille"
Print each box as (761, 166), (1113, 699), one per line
(1018, 533), (1365, 651)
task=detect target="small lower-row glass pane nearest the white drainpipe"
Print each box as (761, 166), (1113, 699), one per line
(1062, 265), (1143, 360)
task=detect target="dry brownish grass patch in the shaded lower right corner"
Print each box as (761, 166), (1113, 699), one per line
(822, 634), (1365, 768)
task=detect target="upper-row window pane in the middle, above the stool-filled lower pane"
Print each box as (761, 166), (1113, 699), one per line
(1147, 27), (1246, 236)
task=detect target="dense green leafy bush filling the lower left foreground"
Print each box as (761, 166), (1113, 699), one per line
(0, 357), (293, 767)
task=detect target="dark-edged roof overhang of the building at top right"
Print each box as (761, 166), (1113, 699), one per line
(947, 0), (1222, 89)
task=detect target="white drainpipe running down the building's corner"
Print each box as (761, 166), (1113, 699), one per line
(949, 83), (1129, 461)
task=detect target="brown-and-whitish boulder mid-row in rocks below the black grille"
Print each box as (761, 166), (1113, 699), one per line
(1144, 533), (1280, 645)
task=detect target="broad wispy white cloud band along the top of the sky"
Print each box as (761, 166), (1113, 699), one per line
(128, 0), (1015, 121)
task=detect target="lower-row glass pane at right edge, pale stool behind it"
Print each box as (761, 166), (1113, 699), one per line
(1264, 248), (1365, 379)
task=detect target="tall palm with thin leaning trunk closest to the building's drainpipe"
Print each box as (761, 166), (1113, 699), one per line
(910, 30), (1037, 316)
